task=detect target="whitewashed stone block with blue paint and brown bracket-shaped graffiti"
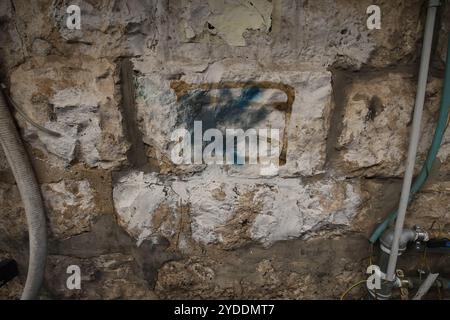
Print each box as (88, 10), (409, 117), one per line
(136, 61), (332, 176)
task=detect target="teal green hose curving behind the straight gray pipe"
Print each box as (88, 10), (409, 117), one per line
(369, 35), (450, 243)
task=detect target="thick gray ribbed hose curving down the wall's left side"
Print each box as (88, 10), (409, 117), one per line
(0, 91), (47, 300)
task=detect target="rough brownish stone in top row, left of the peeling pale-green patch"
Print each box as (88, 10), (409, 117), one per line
(49, 0), (159, 58)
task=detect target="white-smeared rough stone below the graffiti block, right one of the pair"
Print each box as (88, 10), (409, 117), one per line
(252, 180), (362, 244)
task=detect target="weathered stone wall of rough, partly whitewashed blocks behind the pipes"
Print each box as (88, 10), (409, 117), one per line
(0, 0), (450, 299)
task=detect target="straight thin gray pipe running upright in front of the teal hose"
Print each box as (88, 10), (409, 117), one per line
(386, 0), (440, 281)
